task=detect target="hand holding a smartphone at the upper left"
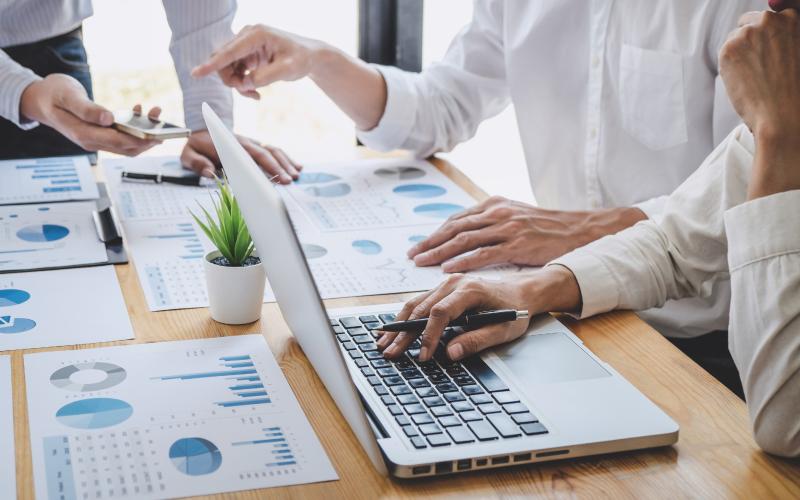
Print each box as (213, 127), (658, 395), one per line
(20, 74), (161, 156)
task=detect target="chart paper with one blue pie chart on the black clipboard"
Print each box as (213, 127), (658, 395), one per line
(0, 201), (108, 272)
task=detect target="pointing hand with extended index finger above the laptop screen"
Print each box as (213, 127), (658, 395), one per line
(192, 25), (322, 99)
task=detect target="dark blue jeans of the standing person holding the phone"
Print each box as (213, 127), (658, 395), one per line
(0, 28), (92, 159)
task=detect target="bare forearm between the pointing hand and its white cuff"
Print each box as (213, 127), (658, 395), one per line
(309, 44), (387, 130)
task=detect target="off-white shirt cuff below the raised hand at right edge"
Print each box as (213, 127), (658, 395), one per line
(725, 190), (800, 272)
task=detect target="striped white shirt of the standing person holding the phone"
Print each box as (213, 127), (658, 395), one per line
(0, 0), (236, 130)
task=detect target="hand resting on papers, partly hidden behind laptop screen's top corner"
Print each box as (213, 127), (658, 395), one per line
(181, 130), (303, 184)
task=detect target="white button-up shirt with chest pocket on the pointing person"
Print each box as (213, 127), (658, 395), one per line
(359, 0), (764, 337)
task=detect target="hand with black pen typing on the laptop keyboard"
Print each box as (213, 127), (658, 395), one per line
(377, 266), (581, 361)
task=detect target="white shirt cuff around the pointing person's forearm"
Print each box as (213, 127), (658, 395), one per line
(356, 65), (417, 151)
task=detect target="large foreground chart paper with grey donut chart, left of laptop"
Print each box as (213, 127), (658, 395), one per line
(25, 335), (337, 500)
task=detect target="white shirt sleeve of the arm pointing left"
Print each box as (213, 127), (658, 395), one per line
(357, 0), (510, 157)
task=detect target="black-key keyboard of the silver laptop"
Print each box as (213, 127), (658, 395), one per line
(330, 314), (548, 449)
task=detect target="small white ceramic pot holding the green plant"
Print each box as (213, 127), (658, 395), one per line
(203, 250), (267, 325)
